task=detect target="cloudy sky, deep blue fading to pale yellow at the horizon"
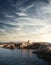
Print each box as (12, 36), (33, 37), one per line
(0, 0), (51, 42)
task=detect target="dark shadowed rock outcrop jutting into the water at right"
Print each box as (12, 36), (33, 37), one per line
(32, 46), (51, 60)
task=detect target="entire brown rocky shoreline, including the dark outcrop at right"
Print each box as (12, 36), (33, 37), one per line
(0, 40), (51, 60)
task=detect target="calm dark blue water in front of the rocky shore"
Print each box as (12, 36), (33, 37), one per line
(0, 48), (51, 65)
